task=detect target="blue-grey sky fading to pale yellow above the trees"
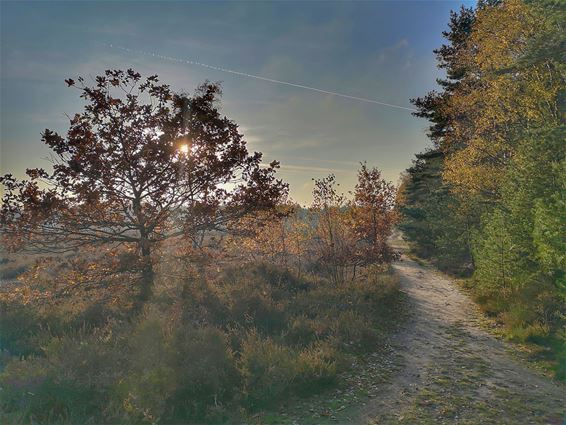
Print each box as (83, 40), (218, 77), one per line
(0, 1), (473, 205)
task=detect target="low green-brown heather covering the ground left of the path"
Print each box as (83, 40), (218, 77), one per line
(0, 266), (404, 424)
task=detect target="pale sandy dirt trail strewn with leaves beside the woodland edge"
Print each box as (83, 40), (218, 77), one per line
(362, 258), (566, 424)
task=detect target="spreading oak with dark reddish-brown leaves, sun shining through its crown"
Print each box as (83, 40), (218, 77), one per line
(0, 69), (287, 300)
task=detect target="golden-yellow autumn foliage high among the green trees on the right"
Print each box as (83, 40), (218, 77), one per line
(442, 0), (563, 197)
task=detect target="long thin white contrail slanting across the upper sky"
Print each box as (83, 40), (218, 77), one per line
(109, 44), (417, 112)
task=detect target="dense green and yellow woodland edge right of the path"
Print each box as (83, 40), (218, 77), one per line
(399, 0), (566, 378)
